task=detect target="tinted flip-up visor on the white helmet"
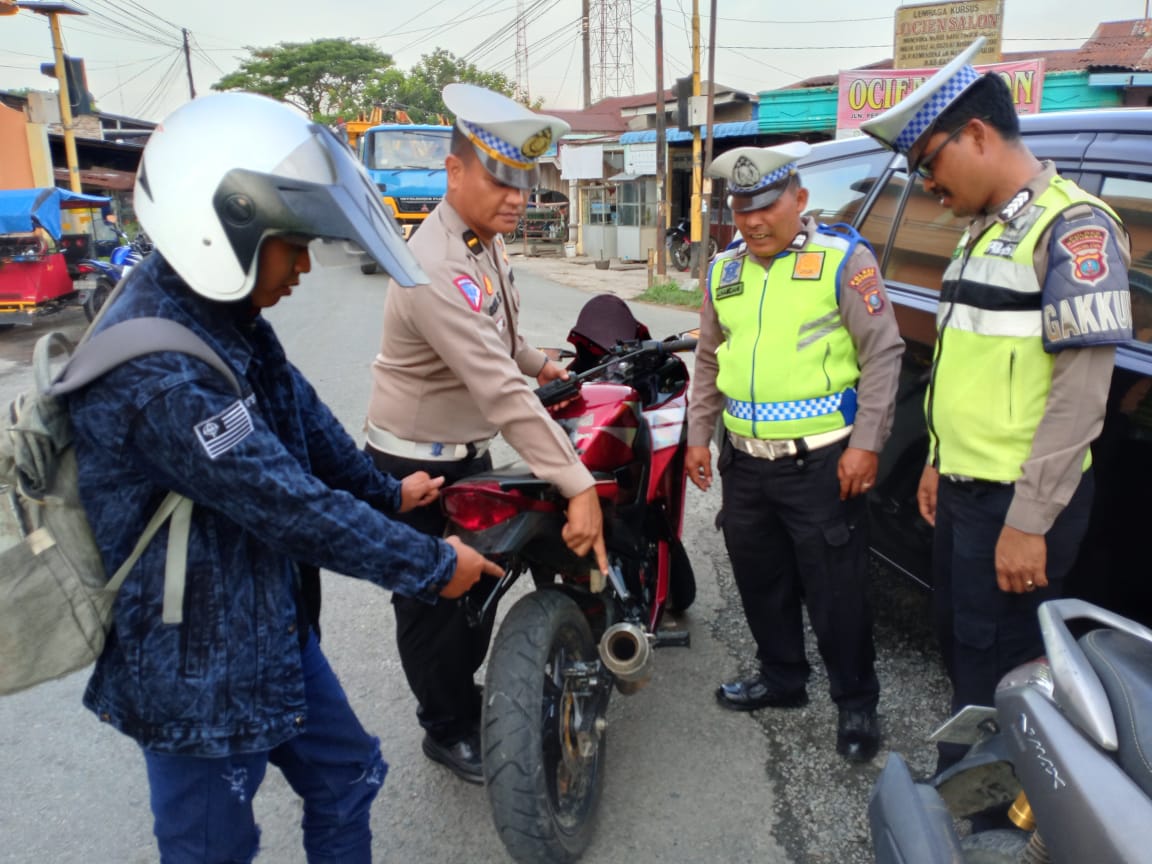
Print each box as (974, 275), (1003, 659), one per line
(213, 124), (427, 287)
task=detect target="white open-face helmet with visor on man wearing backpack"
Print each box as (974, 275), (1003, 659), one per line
(135, 93), (427, 301)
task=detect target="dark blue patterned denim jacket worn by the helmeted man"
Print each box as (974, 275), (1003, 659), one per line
(69, 253), (456, 756)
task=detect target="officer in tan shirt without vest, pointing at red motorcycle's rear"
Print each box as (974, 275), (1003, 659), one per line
(366, 84), (607, 783)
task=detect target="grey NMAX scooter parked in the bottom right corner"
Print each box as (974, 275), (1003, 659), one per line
(869, 599), (1152, 864)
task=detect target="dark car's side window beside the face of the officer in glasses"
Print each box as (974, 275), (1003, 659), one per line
(861, 173), (969, 291)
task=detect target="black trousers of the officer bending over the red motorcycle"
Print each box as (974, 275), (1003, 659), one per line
(364, 446), (492, 744)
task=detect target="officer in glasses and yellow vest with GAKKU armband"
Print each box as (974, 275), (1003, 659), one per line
(862, 38), (1131, 768)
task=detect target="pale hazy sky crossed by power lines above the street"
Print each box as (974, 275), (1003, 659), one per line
(0, 0), (1149, 120)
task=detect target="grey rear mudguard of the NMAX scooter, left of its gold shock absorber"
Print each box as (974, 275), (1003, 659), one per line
(867, 753), (964, 864)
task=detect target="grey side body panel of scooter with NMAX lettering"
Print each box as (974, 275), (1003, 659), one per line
(996, 685), (1152, 864)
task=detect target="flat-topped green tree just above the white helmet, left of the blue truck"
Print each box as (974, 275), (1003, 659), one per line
(212, 39), (394, 122)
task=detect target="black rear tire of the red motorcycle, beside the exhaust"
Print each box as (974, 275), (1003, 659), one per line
(480, 590), (606, 864)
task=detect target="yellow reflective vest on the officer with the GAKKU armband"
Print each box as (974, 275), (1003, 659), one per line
(925, 176), (1120, 483)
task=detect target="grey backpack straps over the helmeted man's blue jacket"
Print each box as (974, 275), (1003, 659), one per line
(49, 318), (244, 624)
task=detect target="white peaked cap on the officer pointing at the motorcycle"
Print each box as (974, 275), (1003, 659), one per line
(441, 83), (571, 189)
